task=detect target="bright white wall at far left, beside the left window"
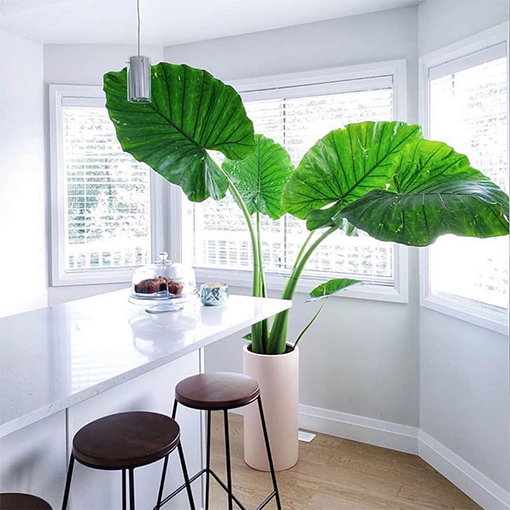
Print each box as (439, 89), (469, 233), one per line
(0, 32), (48, 317)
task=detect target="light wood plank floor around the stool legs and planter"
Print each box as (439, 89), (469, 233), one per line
(205, 413), (480, 510)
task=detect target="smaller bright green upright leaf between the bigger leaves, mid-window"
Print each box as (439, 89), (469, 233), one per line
(223, 135), (294, 220)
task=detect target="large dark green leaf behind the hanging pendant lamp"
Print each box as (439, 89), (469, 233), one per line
(104, 63), (255, 202)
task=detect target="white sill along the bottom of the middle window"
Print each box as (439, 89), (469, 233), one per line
(195, 268), (409, 304)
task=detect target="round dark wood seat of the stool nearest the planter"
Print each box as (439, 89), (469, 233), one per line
(175, 372), (260, 411)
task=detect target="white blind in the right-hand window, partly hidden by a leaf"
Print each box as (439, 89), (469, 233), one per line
(429, 50), (509, 310)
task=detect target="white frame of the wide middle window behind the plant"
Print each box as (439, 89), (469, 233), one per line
(169, 60), (409, 303)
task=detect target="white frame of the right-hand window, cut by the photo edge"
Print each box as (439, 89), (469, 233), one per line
(419, 22), (510, 336)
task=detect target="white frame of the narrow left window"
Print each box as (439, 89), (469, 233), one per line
(49, 84), (165, 287)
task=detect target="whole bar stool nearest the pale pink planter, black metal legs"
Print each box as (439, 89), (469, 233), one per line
(154, 372), (282, 510)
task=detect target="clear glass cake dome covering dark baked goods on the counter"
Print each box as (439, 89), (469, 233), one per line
(131, 251), (197, 301)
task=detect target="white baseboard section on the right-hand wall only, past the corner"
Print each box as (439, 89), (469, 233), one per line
(418, 430), (510, 510)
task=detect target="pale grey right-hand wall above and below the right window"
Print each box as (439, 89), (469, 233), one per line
(419, 0), (510, 496)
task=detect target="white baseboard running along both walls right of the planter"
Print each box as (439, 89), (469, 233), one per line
(299, 405), (510, 510)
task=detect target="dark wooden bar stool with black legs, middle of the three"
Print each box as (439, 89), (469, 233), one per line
(62, 411), (195, 510)
